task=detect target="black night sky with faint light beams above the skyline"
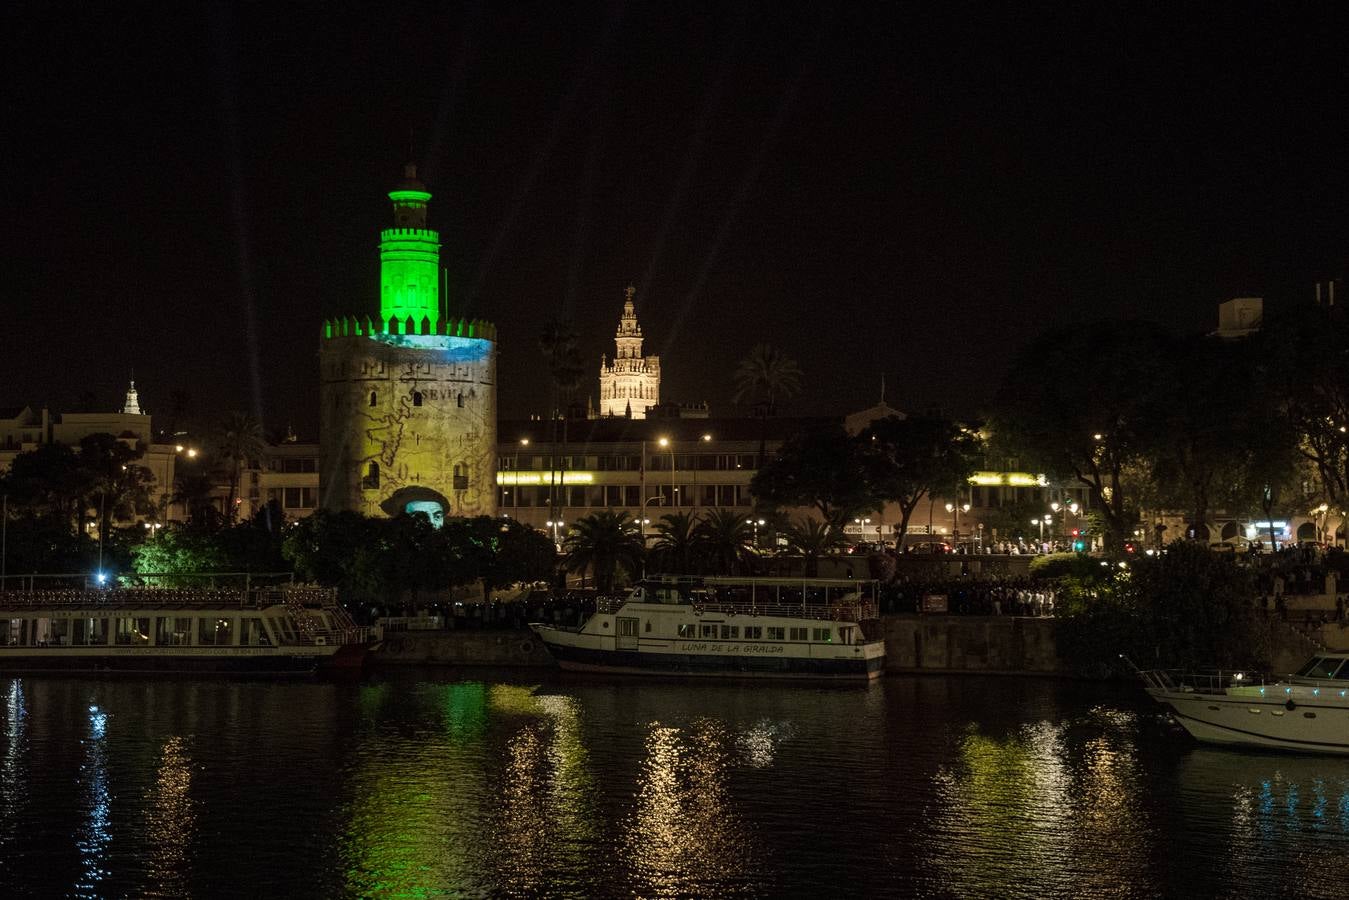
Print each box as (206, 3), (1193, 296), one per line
(0, 1), (1349, 436)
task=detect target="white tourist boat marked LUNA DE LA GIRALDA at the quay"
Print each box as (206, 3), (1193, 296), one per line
(530, 575), (885, 680)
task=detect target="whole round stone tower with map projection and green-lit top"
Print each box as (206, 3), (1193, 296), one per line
(318, 165), (496, 526)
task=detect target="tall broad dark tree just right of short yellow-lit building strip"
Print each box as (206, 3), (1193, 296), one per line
(992, 322), (1171, 549)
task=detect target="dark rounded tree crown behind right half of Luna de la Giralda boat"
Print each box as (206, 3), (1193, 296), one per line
(750, 425), (881, 519)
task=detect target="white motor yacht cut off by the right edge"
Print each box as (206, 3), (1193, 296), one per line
(1139, 652), (1349, 754)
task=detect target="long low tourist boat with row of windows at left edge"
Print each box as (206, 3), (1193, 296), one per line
(0, 587), (371, 675)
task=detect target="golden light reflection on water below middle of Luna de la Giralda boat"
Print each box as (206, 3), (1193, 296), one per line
(623, 719), (765, 897)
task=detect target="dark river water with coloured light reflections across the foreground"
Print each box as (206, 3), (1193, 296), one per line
(0, 671), (1349, 897)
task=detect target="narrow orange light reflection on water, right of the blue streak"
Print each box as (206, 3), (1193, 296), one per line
(144, 737), (197, 897)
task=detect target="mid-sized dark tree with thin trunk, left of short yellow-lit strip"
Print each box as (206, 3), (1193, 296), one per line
(858, 414), (981, 548)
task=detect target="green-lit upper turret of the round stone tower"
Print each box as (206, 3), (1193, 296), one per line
(379, 163), (440, 333)
